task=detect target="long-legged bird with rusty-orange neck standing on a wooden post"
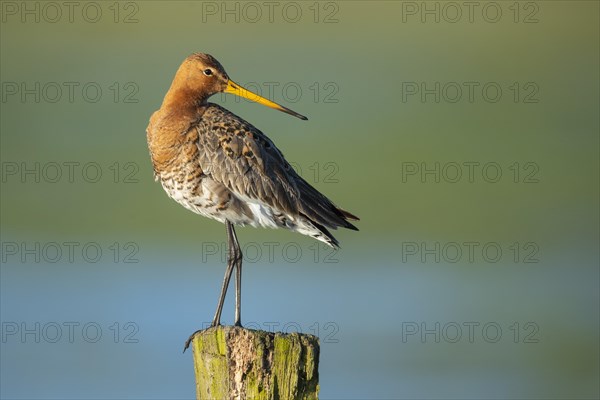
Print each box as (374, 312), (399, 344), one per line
(146, 53), (359, 351)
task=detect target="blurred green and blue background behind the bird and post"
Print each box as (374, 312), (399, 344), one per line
(0, 1), (600, 399)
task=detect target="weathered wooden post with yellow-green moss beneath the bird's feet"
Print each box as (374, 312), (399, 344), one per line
(192, 326), (319, 400)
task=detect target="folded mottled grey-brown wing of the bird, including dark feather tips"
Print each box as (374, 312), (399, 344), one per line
(198, 103), (358, 233)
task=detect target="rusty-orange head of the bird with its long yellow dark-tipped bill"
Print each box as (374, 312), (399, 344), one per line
(174, 53), (308, 120)
